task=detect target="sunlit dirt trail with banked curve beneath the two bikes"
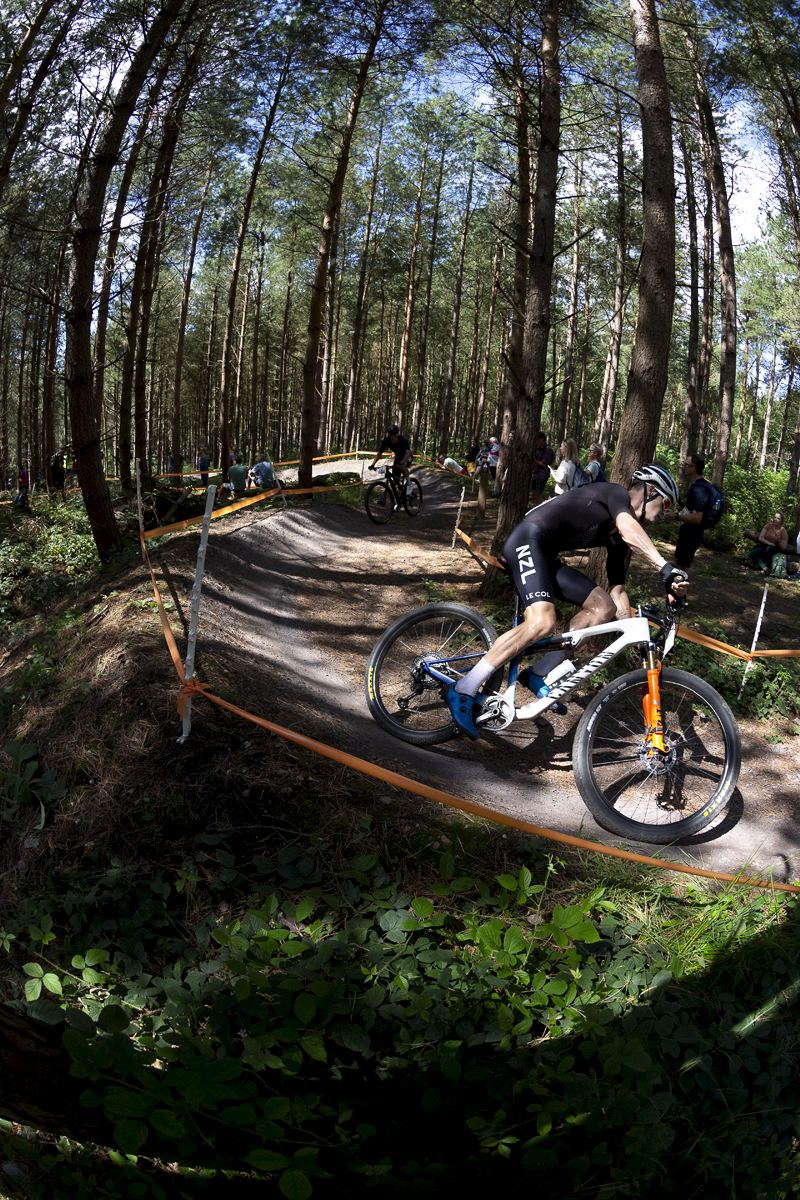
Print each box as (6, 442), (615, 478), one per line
(201, 464), (800, 881)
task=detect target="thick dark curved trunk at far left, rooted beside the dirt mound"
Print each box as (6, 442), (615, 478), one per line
(65, 0), (185, 560)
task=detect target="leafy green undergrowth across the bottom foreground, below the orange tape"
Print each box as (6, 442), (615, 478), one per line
(0, 830), (800, 1200)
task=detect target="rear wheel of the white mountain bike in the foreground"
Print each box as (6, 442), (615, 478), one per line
(365, 604), (503, 746)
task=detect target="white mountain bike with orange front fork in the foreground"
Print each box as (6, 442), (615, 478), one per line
(366, 600), (741, 844)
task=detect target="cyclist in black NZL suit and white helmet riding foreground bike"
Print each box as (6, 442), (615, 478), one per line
(445, 463), (688, 738)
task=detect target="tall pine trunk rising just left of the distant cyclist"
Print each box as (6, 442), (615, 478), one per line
(297, 0), (389, 487)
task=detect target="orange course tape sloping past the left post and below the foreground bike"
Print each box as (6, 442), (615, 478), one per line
(142, 538), (800, 894)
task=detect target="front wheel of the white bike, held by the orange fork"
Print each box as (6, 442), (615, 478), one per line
(572, 670), (741, 844)
